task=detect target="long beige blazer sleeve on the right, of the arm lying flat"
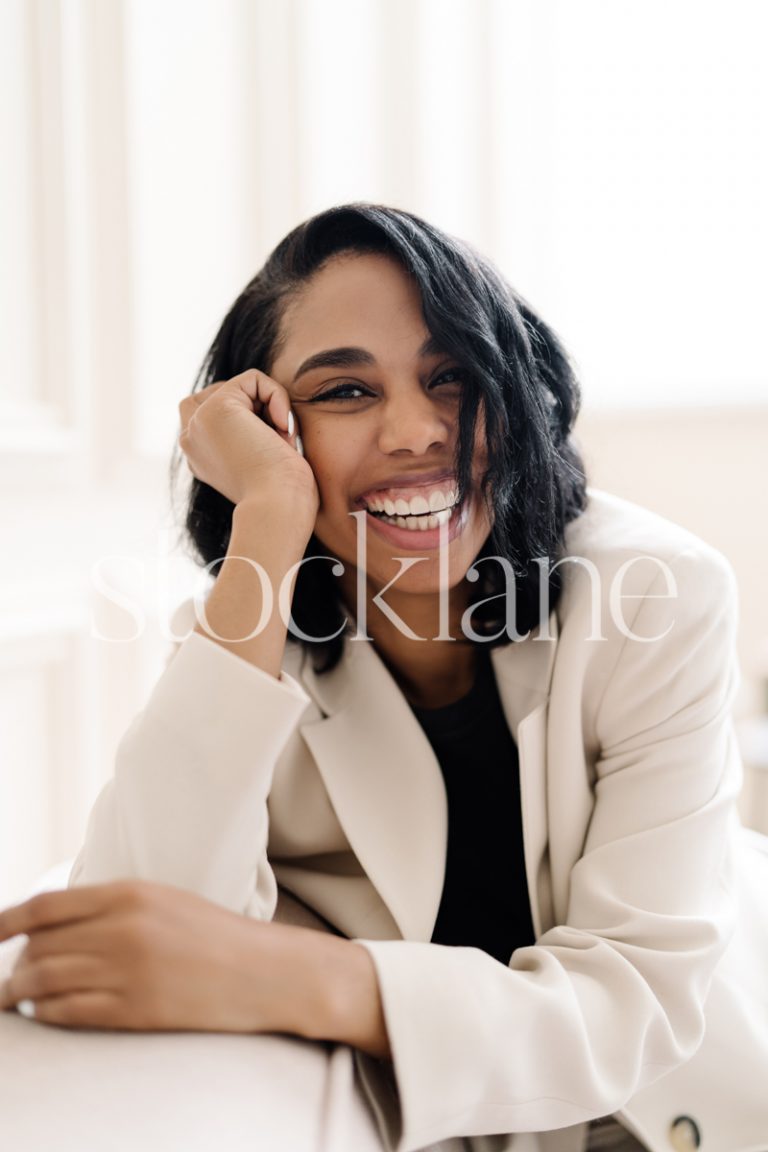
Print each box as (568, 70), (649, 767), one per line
(357, 548), (740, 1152)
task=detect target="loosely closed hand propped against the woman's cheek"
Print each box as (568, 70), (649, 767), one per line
(178, 369), (319, 525)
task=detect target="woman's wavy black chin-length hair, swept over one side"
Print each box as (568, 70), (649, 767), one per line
(170, 204), (586, 670)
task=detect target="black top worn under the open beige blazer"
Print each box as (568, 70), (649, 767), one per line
(413, 652), (534, 964)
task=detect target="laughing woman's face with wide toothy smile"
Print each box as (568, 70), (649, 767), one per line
(269, 253), (491, 592)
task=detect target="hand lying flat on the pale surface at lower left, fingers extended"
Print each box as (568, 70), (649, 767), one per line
(0, 880), (318, 1034)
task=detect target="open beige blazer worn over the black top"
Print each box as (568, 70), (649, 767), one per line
(71, 492), (768, 1152)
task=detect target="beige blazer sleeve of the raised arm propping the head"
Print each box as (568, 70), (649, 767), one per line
(69, 631), (307, 919)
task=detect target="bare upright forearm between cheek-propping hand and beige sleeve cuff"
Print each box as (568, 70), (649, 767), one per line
(195, 501), (312, 677)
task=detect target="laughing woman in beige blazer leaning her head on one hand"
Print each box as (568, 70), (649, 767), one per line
(0, 205), (768, 1152)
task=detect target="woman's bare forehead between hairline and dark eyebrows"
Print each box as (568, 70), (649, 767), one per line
(274, 253), (428, 369)
